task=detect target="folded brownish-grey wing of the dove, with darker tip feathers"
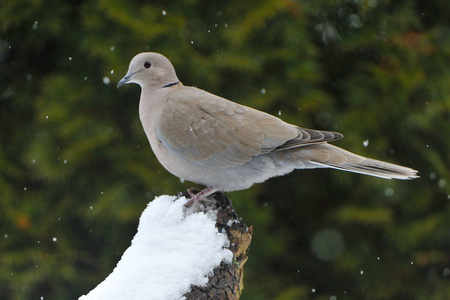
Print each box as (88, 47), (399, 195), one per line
(156, 87), (342, 168)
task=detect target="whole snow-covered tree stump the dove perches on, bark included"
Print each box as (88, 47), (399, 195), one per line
(79, 193), (252, 300)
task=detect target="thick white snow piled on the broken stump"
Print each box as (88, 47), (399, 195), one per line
(79, 196), (233, 300)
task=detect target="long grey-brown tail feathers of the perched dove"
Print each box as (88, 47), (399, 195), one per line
(296, 143), (419, 180)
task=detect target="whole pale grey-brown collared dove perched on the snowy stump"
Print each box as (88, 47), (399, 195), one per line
(117, 52), (419, 203)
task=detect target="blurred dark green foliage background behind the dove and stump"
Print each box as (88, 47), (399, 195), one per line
(0, 0), (450, 300)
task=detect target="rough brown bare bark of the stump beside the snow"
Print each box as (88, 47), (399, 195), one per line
(183, 192), (252, 300)
